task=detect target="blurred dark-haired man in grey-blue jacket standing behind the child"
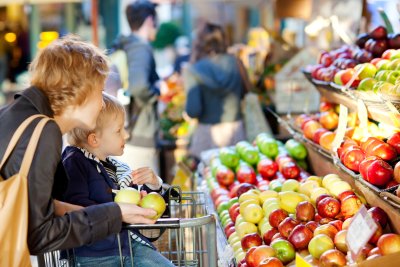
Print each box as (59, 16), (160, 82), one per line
(111, 0), (160, 172)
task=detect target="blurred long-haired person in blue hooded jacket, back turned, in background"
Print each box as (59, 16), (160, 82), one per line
(184, 23), (245, 157)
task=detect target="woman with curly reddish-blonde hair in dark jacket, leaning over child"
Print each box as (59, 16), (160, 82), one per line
(0, 36), (156, 254)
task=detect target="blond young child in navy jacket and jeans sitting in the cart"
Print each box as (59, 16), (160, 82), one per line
(62, 94), (174, 266)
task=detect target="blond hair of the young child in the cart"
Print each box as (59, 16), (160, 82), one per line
(68, 93), (125, 146)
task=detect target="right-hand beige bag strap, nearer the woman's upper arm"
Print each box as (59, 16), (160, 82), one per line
(19, 118), (51, 177)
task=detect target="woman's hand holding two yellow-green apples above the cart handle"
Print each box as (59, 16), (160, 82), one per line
(118, 203), (157, 224)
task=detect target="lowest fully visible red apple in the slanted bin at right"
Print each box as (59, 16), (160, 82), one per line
(363, 159), (393, 186)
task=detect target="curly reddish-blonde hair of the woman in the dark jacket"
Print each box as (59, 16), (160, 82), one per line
(29, 35), (109, 115)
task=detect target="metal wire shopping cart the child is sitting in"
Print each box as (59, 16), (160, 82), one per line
(38, 187), (218, 267)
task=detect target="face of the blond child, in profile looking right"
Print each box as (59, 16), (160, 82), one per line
(96, 114), (128, 158)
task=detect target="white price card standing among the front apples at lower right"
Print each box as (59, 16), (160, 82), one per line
(346, 205), (378, 260)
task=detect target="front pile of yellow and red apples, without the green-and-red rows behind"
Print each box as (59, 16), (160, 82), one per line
(211, 169), (400, 267)
